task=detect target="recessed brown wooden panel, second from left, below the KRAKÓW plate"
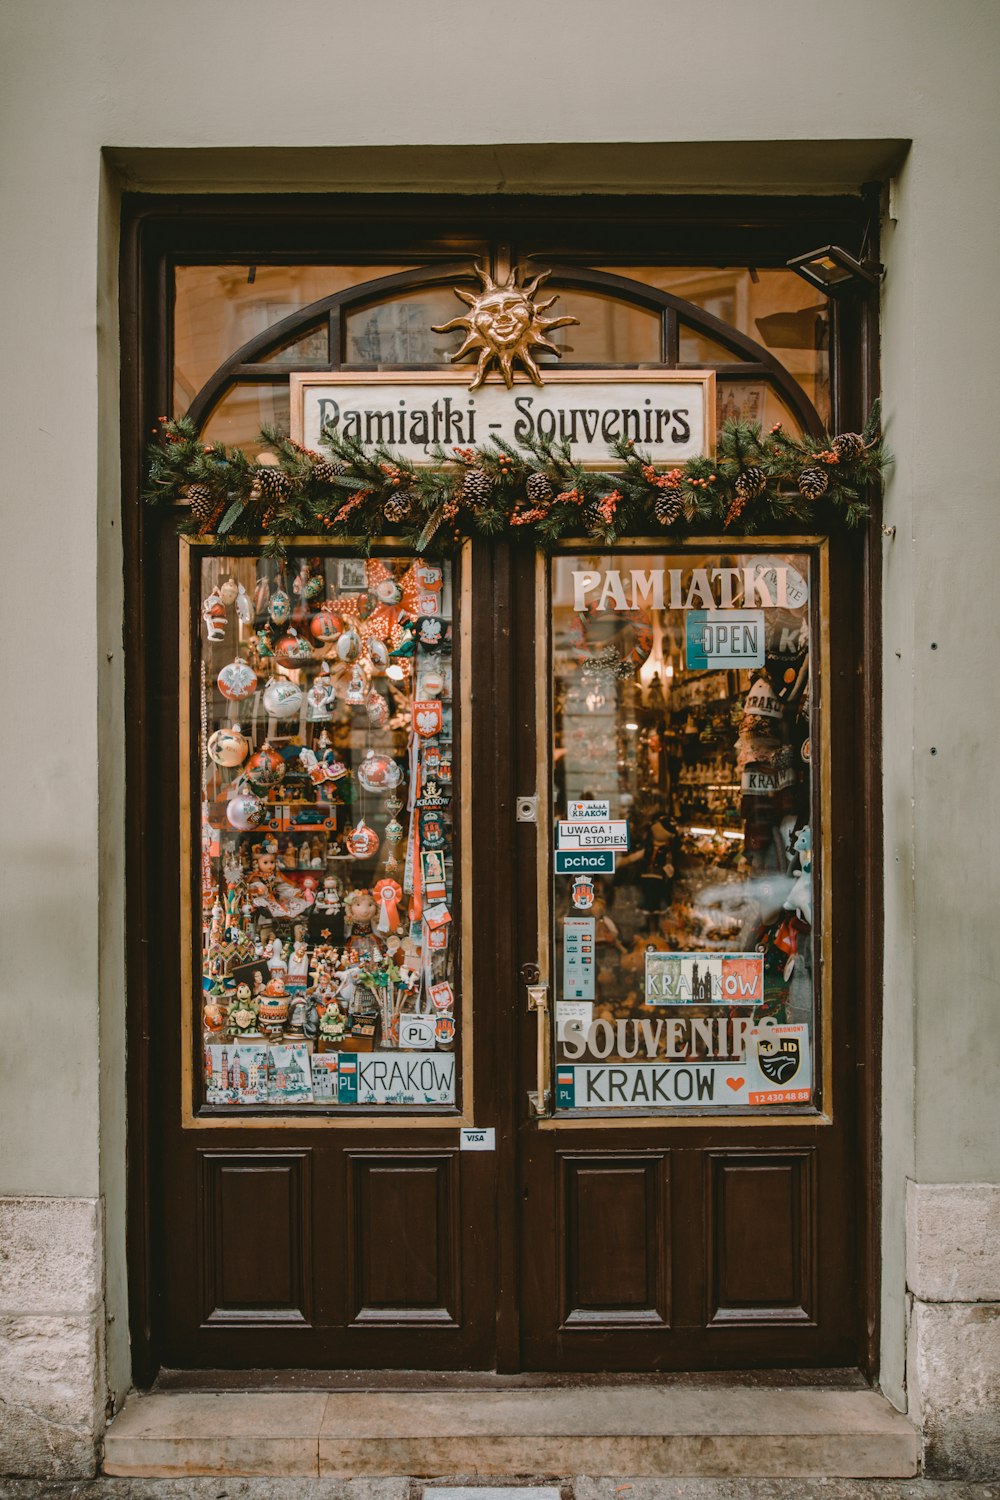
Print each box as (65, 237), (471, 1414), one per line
(348, 1152), (460, 1326)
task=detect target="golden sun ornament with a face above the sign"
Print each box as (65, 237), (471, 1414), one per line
(433, 264), (580, 390)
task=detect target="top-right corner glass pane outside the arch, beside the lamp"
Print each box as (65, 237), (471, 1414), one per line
(600, 266), (831, 423)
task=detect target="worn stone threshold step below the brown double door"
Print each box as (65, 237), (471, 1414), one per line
(103, 1385), (918, 1479)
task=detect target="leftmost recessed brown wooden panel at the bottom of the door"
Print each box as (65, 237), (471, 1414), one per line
(201, 1151), (312, 1325)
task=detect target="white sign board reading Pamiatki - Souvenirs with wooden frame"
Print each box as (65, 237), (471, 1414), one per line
(291, 369), (715, 467)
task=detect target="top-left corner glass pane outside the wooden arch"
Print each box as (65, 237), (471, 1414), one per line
(174, 263), (408, 417)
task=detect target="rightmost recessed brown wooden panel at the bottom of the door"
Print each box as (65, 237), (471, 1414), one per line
(705, 1151), (816, 1323)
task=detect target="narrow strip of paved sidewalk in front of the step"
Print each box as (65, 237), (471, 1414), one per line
(0, 1476), (1000, 1500)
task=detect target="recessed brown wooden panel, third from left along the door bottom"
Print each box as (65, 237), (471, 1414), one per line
(559, 1152), (670, 1328)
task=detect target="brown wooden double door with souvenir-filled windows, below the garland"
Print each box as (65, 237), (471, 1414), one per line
(145, 522), (865, 1371)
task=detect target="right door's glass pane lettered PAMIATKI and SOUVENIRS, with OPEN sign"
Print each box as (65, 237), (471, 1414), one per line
(550, 549), (820, 1115)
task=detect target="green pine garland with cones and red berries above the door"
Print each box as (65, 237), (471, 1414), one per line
(142, 402), (891, 555)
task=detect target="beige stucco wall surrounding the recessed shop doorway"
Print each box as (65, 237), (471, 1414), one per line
(0, 0), (1000, 1476)
